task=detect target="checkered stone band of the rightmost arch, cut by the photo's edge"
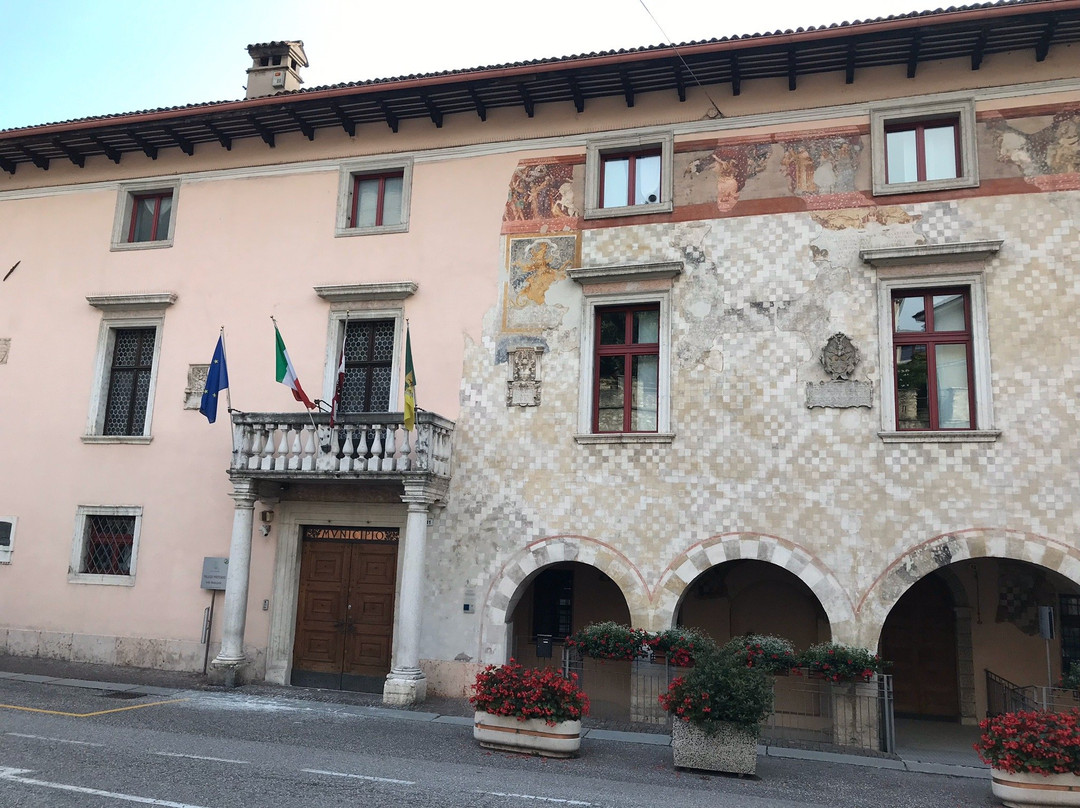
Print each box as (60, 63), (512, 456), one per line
(855, 527), (1080, 648)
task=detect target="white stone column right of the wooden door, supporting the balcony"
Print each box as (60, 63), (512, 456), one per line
(382, 481), (437, 704)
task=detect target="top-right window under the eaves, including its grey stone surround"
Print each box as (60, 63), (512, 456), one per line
(870, 102), (978, 194)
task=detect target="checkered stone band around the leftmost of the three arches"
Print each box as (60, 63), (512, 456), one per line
(478, 536), (650, 663)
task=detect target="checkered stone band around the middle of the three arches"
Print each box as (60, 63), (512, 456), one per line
(654, 533), (855, 642)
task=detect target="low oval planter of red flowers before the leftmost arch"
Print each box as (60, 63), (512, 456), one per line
(469, 659), (589, 757)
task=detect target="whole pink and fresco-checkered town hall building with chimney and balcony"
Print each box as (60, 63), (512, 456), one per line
(0, 0), (1080, 721)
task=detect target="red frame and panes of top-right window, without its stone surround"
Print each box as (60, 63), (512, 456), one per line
(885, 117), (962, 185)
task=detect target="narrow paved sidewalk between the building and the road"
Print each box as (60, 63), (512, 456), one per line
(0, 656), (989, 779)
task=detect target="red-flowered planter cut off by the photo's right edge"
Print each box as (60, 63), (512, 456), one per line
(975, 708), (1080, 808)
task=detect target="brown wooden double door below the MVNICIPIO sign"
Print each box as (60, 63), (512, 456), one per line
(292, 526), (397, 692)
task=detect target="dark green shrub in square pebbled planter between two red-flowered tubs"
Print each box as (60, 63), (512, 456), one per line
(660, 649), (772, 775)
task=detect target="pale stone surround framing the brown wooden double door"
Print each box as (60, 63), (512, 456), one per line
(266, 501), (408, 685)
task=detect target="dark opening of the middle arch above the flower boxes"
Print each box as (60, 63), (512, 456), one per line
(676, 560), (832, 650)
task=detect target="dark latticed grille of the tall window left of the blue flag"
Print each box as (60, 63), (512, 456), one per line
(102, 326), (158, 435)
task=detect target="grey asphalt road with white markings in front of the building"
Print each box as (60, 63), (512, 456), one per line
(0, 681), (998, 808)
